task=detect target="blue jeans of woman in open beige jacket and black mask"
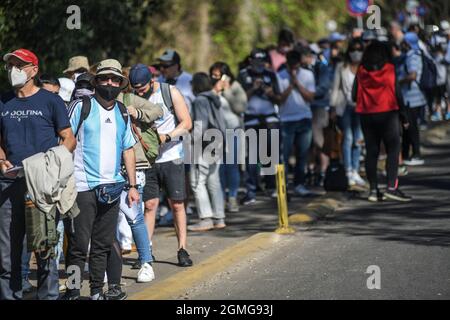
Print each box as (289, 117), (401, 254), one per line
(339, 106), (362, 171)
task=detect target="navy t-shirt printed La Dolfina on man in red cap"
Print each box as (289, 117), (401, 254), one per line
(0, 89), (70, 165)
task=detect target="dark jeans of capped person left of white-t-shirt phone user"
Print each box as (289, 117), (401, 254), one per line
(245, 123), (281, 198)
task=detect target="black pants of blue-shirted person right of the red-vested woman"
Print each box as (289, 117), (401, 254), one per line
(402, 107), (425, 159)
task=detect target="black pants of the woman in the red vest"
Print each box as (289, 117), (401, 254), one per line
(361, 111), (400, 190)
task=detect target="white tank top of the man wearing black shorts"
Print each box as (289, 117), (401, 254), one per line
(148, 86), (184, 163)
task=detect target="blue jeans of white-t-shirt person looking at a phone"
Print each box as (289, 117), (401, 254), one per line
(281, 119), (312, 186)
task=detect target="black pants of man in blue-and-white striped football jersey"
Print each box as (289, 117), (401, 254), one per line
(65, 191), (119, 295)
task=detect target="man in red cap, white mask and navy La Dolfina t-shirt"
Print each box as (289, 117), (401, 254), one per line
(0, 49), (76, 300)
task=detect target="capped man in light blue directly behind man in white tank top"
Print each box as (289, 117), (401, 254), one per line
(158, 49), (195, 110)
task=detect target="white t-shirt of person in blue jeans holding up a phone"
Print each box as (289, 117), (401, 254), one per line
(278, 68), (316, 122)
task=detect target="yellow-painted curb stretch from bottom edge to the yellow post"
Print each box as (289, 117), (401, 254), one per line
(129, 232), (283, 300)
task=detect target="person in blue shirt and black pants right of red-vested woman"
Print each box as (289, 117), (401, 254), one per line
(399, 32), (427, 166)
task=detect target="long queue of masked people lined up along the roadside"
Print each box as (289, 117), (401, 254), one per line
(0, 16), (450, 300)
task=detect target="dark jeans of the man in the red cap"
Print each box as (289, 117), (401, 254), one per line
(0, 179), (59, 300)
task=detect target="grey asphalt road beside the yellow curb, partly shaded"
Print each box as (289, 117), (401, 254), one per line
(184, 127), (450, 300)
